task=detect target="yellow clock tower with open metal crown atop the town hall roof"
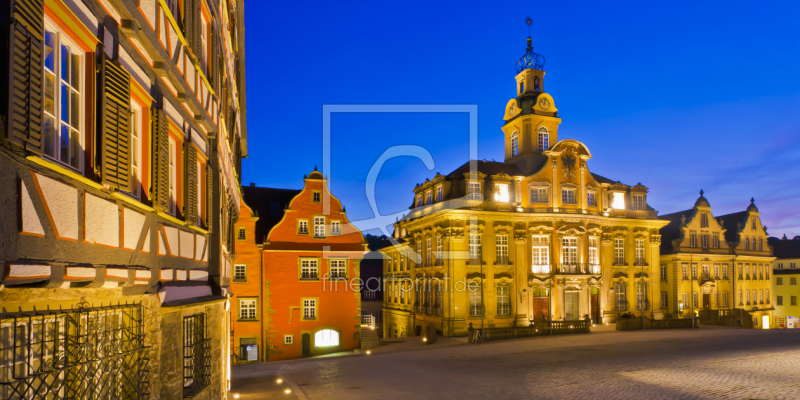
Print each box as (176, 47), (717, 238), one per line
(502, 24), (561, 174)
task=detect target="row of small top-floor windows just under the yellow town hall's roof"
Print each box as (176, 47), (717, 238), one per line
(415, 182), (646, 210)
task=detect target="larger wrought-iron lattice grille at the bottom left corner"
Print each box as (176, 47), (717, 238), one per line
(0, 299), (150, 400)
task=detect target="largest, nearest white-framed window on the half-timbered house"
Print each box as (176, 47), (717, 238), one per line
(40, 18), (85, 170)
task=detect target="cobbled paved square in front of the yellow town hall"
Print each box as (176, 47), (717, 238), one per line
(232, 327), (800, 400)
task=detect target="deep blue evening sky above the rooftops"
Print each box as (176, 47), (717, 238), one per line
(242, 0), (800, 237)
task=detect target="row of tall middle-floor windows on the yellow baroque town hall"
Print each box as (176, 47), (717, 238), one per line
(386, 234), (647, 274)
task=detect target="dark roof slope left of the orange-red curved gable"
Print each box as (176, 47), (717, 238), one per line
(242, 186), (302, 244)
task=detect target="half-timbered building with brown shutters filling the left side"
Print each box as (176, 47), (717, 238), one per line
(0, 0), (247, 400)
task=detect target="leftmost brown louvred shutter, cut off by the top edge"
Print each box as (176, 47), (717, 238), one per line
(5, 0), (44, 155)
